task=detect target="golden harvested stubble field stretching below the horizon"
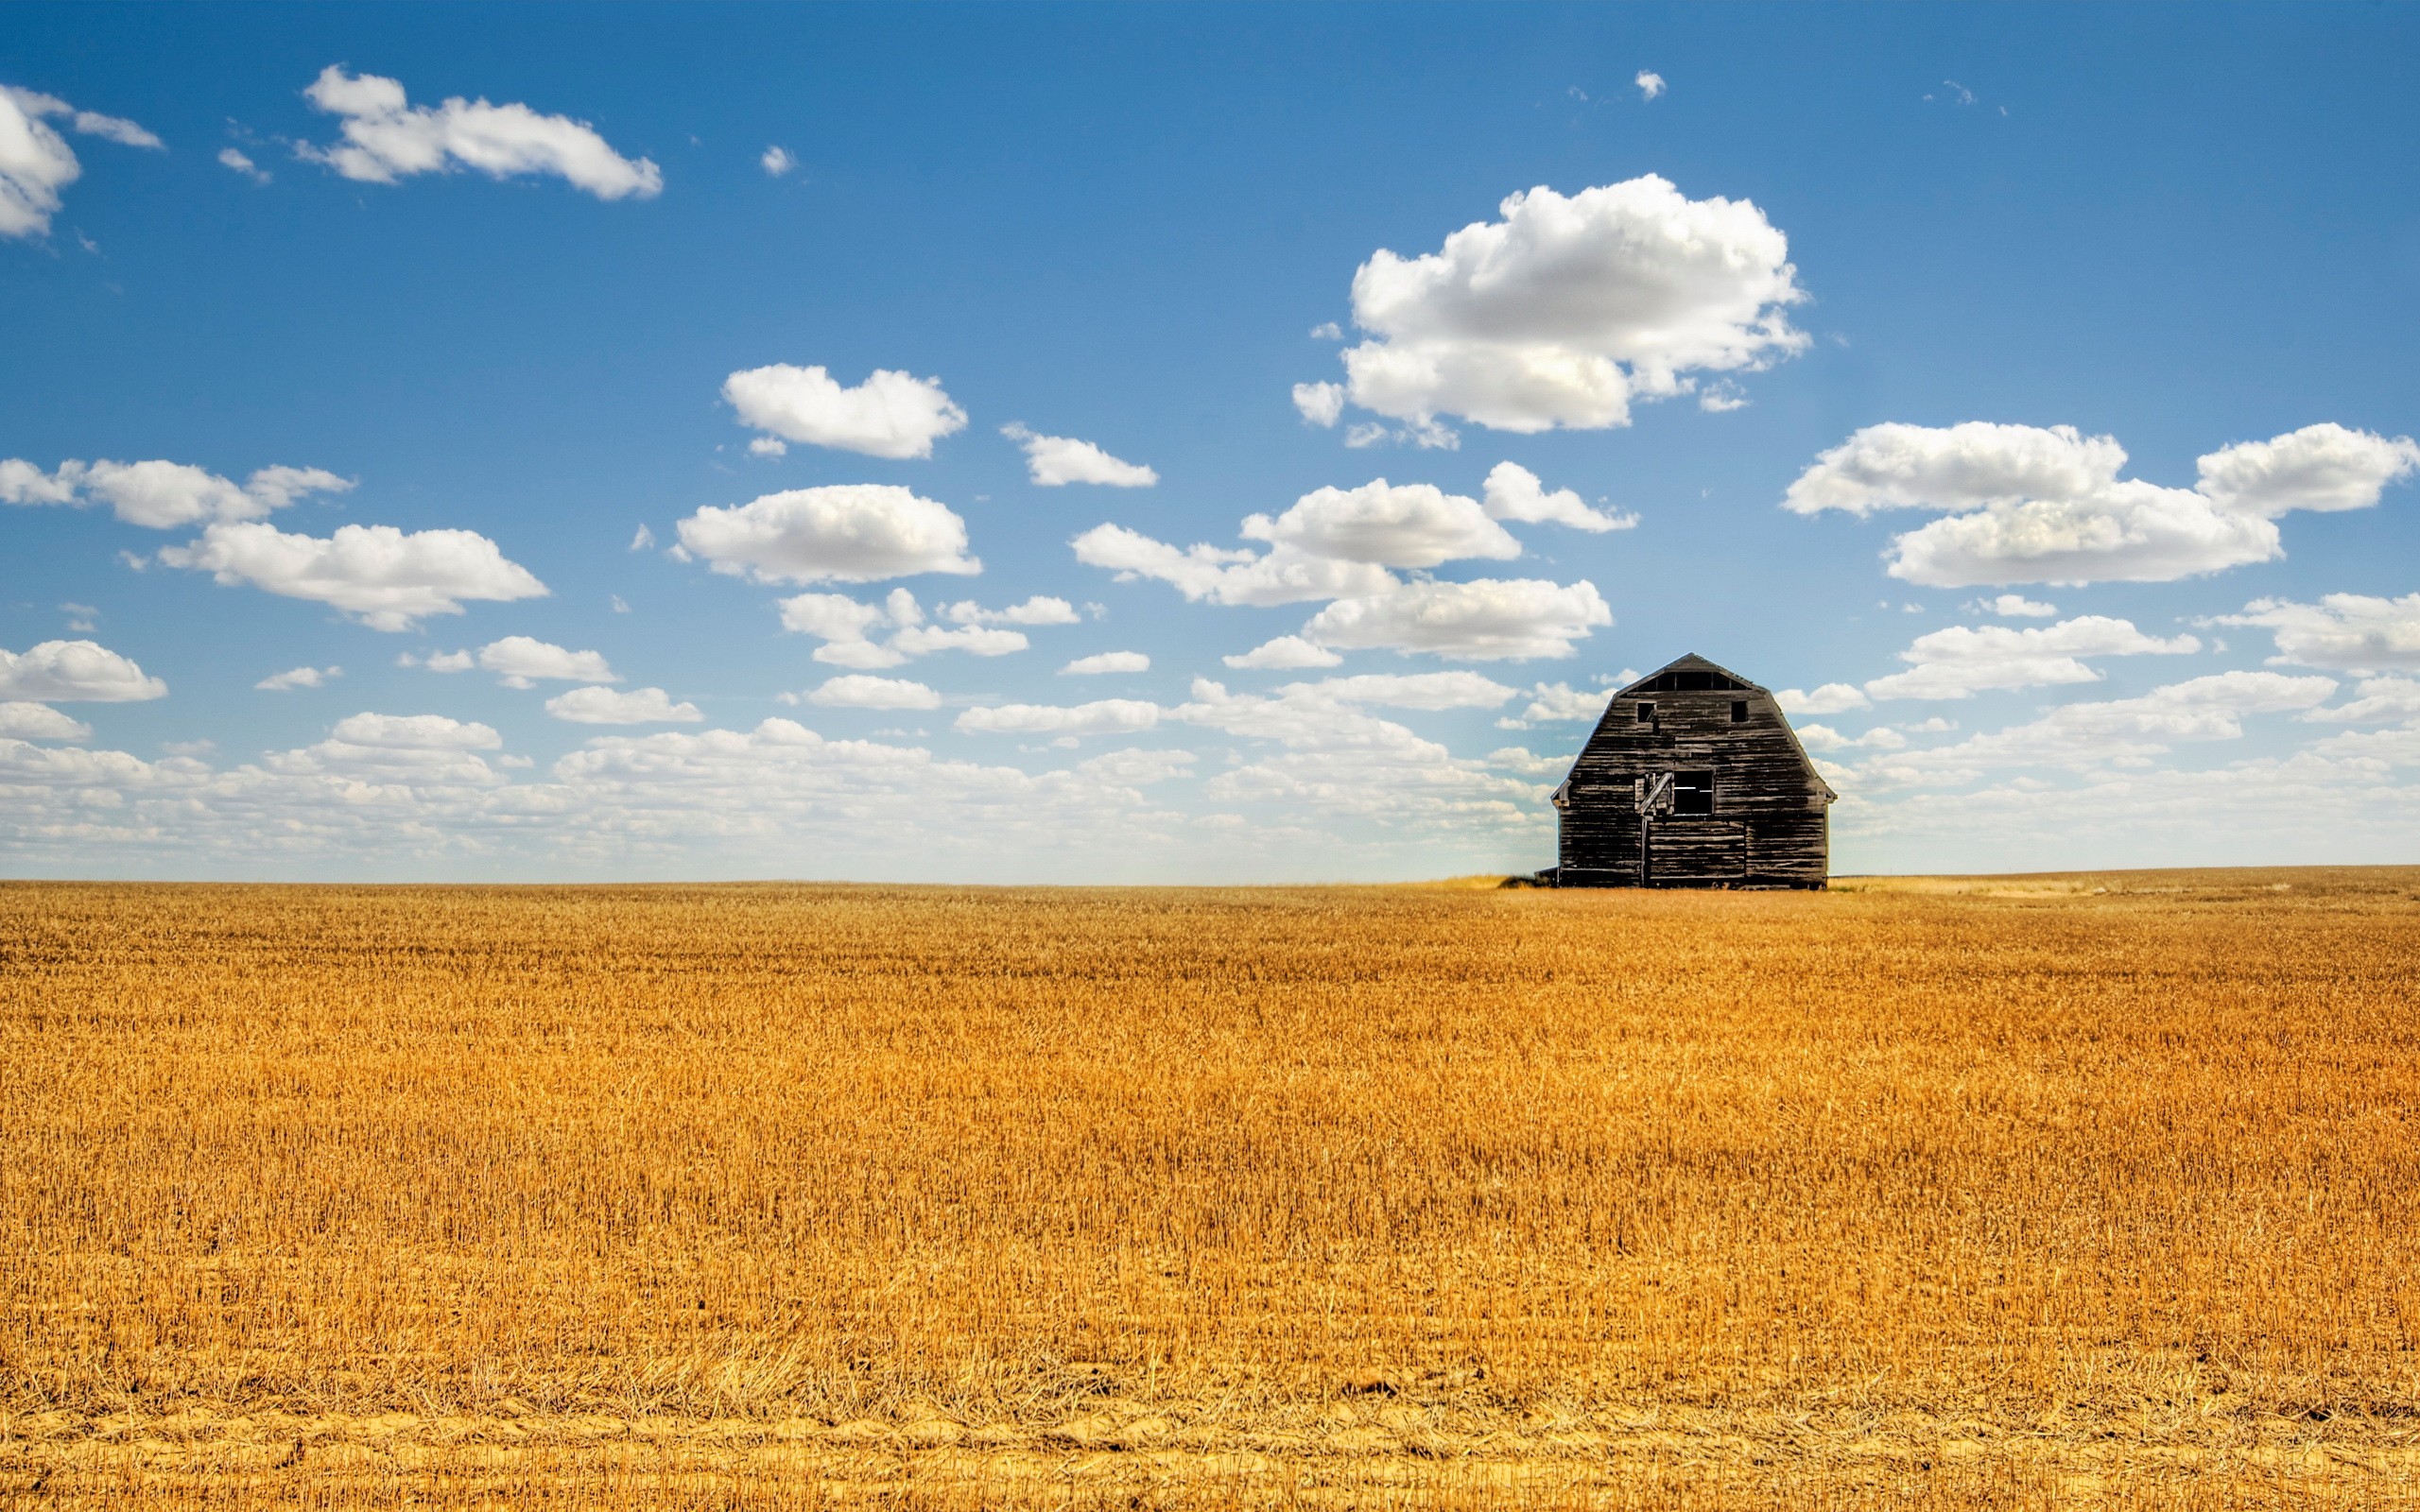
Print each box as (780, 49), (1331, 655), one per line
(0, 868), (2420, 1507)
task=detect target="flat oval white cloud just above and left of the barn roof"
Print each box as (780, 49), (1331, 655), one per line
(1302, 578), (1615, 661)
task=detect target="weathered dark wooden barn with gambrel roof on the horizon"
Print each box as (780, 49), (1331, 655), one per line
(1539, 656), (1840, 888)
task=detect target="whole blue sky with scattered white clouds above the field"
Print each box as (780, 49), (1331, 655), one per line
(0, 8), (2420, 881)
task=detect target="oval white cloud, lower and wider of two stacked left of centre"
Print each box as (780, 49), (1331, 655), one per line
(680, 484), (982, 583)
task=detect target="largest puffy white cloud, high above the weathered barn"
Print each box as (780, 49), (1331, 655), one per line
(1297, 174), (1806, 433)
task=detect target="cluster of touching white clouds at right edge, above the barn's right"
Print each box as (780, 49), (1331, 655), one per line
(1784, 421), (2420, 588)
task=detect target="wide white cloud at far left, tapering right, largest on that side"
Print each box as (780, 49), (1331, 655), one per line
(160, 520), (547, 631)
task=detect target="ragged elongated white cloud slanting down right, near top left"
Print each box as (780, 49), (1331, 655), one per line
(295, 63), (663, 200)
